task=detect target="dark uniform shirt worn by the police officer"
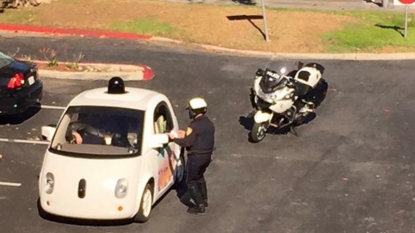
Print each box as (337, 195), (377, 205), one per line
(173, 115), (215, 155)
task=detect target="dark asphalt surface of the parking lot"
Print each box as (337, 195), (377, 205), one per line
(0, 34), (415, 233)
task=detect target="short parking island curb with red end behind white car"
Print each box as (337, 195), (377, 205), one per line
(32, 60), (155, 81)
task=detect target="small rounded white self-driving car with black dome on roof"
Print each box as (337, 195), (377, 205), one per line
(39, 77), (184, 222)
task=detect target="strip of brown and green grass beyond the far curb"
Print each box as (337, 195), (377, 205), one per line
(0, 0), (415, 53)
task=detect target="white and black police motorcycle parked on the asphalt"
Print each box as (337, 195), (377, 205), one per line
(250, 62), (328, 142)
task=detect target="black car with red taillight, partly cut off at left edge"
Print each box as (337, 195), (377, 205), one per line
(0, 52), (43, 115)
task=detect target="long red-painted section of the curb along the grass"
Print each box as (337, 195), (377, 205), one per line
(0, 24), (152, 40)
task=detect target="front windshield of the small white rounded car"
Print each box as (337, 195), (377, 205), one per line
(51, 106), (144, 157)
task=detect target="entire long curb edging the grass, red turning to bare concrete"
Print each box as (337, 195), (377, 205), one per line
(0, 24), (415, 61)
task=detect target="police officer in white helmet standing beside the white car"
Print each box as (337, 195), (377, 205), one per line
(169, 98), (215, 214)
